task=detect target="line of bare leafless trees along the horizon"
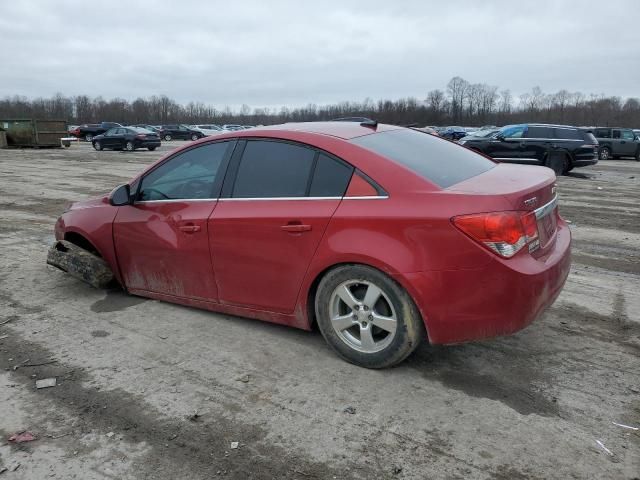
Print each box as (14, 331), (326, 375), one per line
(0, 77), (640, 128)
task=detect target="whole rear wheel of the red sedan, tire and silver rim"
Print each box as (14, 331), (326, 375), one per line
(315, 265), (425, 368)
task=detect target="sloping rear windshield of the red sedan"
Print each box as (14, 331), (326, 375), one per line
(351, 129), (496, 188)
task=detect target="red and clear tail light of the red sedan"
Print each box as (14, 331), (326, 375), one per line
(452, 211), (540, 258)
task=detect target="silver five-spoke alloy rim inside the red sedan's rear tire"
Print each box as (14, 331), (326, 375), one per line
(329, 280), (398, 353)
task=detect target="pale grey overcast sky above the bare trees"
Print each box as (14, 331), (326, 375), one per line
(0, 0), (640, 108)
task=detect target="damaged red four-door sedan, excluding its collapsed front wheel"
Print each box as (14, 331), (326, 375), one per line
(55, 122), (571, 368)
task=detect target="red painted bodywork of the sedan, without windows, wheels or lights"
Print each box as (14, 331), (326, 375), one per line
(55, 122), (571, 343)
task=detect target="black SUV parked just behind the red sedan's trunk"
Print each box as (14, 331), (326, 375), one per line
(463, 123), (598, 175)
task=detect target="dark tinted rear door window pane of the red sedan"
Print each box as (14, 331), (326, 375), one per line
(231, 140), (316, 198)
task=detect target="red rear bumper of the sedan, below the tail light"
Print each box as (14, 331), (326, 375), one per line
(398, 221), (571, 344)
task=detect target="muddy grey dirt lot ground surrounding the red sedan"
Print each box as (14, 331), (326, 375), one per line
(0, 142), (640, 480)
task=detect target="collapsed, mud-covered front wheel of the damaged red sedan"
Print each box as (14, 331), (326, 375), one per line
(47, 240), (114, 288)
